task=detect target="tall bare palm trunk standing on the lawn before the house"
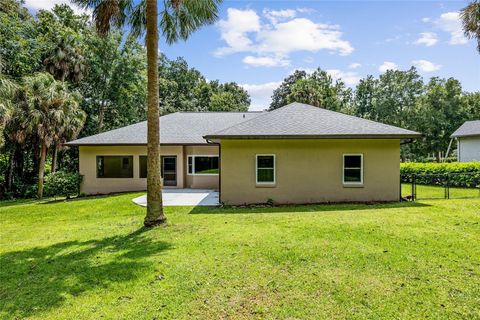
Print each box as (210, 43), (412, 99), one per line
(144, 0), (167, 227)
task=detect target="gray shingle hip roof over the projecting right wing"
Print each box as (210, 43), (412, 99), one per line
(205, 103), (421, 139)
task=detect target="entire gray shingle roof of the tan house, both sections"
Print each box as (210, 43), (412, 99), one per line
(67, 103), (421, 145)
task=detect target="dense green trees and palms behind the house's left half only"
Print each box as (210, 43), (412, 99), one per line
(0, 0), (250, 198)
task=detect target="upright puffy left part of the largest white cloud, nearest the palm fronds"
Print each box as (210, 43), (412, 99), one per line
(215, 8), (260, 56)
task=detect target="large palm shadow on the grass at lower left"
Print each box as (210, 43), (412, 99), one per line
(0, 228), (170, 318)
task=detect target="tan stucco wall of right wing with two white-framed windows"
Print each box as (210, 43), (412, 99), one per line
(220, 139), (400, 205)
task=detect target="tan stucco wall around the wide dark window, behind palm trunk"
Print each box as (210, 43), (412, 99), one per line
(79, 146), (185, 194)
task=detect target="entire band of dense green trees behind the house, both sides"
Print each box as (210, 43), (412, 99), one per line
(0, 0), (480, 198)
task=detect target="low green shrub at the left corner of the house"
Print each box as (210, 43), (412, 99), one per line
(44, 171), (82, 198)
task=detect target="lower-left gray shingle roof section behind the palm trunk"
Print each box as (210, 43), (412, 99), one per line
(67, 112), (262, 145)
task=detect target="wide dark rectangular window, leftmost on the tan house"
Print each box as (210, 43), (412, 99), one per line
(97, 156), (133, 178)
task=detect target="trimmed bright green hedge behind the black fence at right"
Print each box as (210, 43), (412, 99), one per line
(400, 162), (480, 188)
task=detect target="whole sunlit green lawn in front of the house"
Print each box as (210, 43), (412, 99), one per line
(0, 194), (480, 319)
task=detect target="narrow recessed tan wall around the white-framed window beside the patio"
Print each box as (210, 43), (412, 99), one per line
(184, 145), (220, 190)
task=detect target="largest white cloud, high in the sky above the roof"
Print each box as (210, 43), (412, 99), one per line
(215, 8), (354, 66)
